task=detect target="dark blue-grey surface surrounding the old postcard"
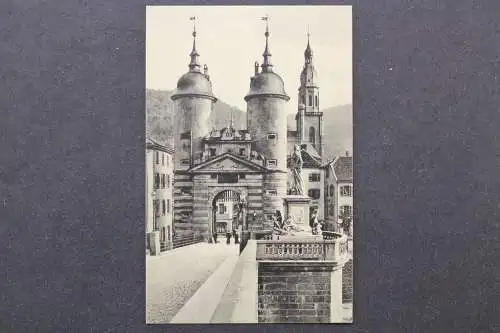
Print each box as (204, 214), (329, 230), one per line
(0, 0), (500, 333)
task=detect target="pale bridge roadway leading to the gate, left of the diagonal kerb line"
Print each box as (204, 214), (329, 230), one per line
(146, 242), (239, 324)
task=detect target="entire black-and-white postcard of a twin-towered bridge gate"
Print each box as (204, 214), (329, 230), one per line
(145, 6), (356, 324)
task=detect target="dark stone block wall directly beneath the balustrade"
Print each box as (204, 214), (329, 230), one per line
(258, 261), (333, 323)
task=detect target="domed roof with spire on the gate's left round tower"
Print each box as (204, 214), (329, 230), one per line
(170, 19), (217, 102)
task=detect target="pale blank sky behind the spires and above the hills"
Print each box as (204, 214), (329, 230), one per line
(146, 6), (353, 113)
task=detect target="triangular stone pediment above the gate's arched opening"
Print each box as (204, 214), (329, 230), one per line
(189, 153), (267, 173)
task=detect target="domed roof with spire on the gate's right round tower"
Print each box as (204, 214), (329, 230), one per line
(245, 18), (290, 101)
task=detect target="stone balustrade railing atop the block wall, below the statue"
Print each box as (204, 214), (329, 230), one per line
(257, 234), (348, 261)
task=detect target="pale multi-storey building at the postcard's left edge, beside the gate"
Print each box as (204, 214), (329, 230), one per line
(146, 138), (174, 251)
